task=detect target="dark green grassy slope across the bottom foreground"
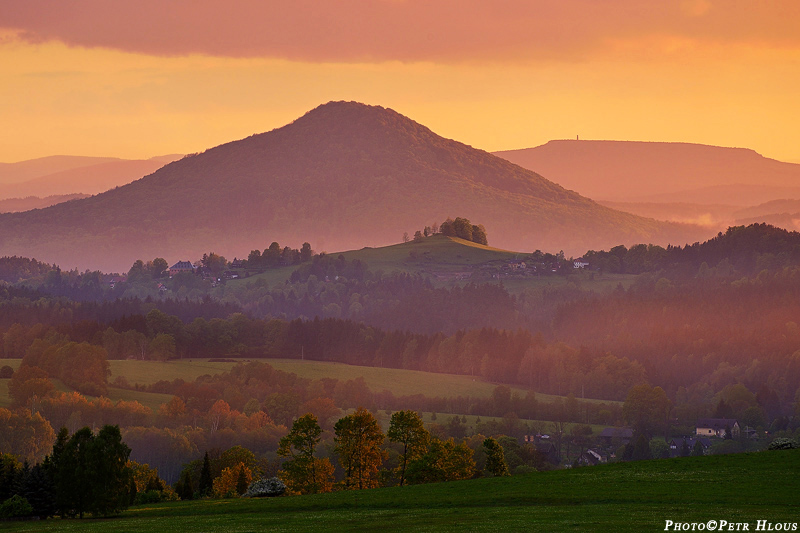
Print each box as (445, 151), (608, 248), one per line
(0, 450), (800, 533)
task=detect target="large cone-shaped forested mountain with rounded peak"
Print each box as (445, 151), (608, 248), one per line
(0, 102), (702, 270)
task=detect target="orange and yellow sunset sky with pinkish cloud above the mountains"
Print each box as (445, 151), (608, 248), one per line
(0, 0), (800, 162)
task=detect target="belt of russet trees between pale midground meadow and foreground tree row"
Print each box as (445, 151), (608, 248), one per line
(0, 352), (798, 488)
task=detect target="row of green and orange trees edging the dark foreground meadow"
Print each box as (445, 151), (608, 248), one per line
(0, 408), (532, 519)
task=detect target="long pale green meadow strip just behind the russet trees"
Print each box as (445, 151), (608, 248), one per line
(109, 359), (611, 403)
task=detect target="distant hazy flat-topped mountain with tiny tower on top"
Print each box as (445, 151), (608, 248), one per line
(495, 140), (800, 205)
